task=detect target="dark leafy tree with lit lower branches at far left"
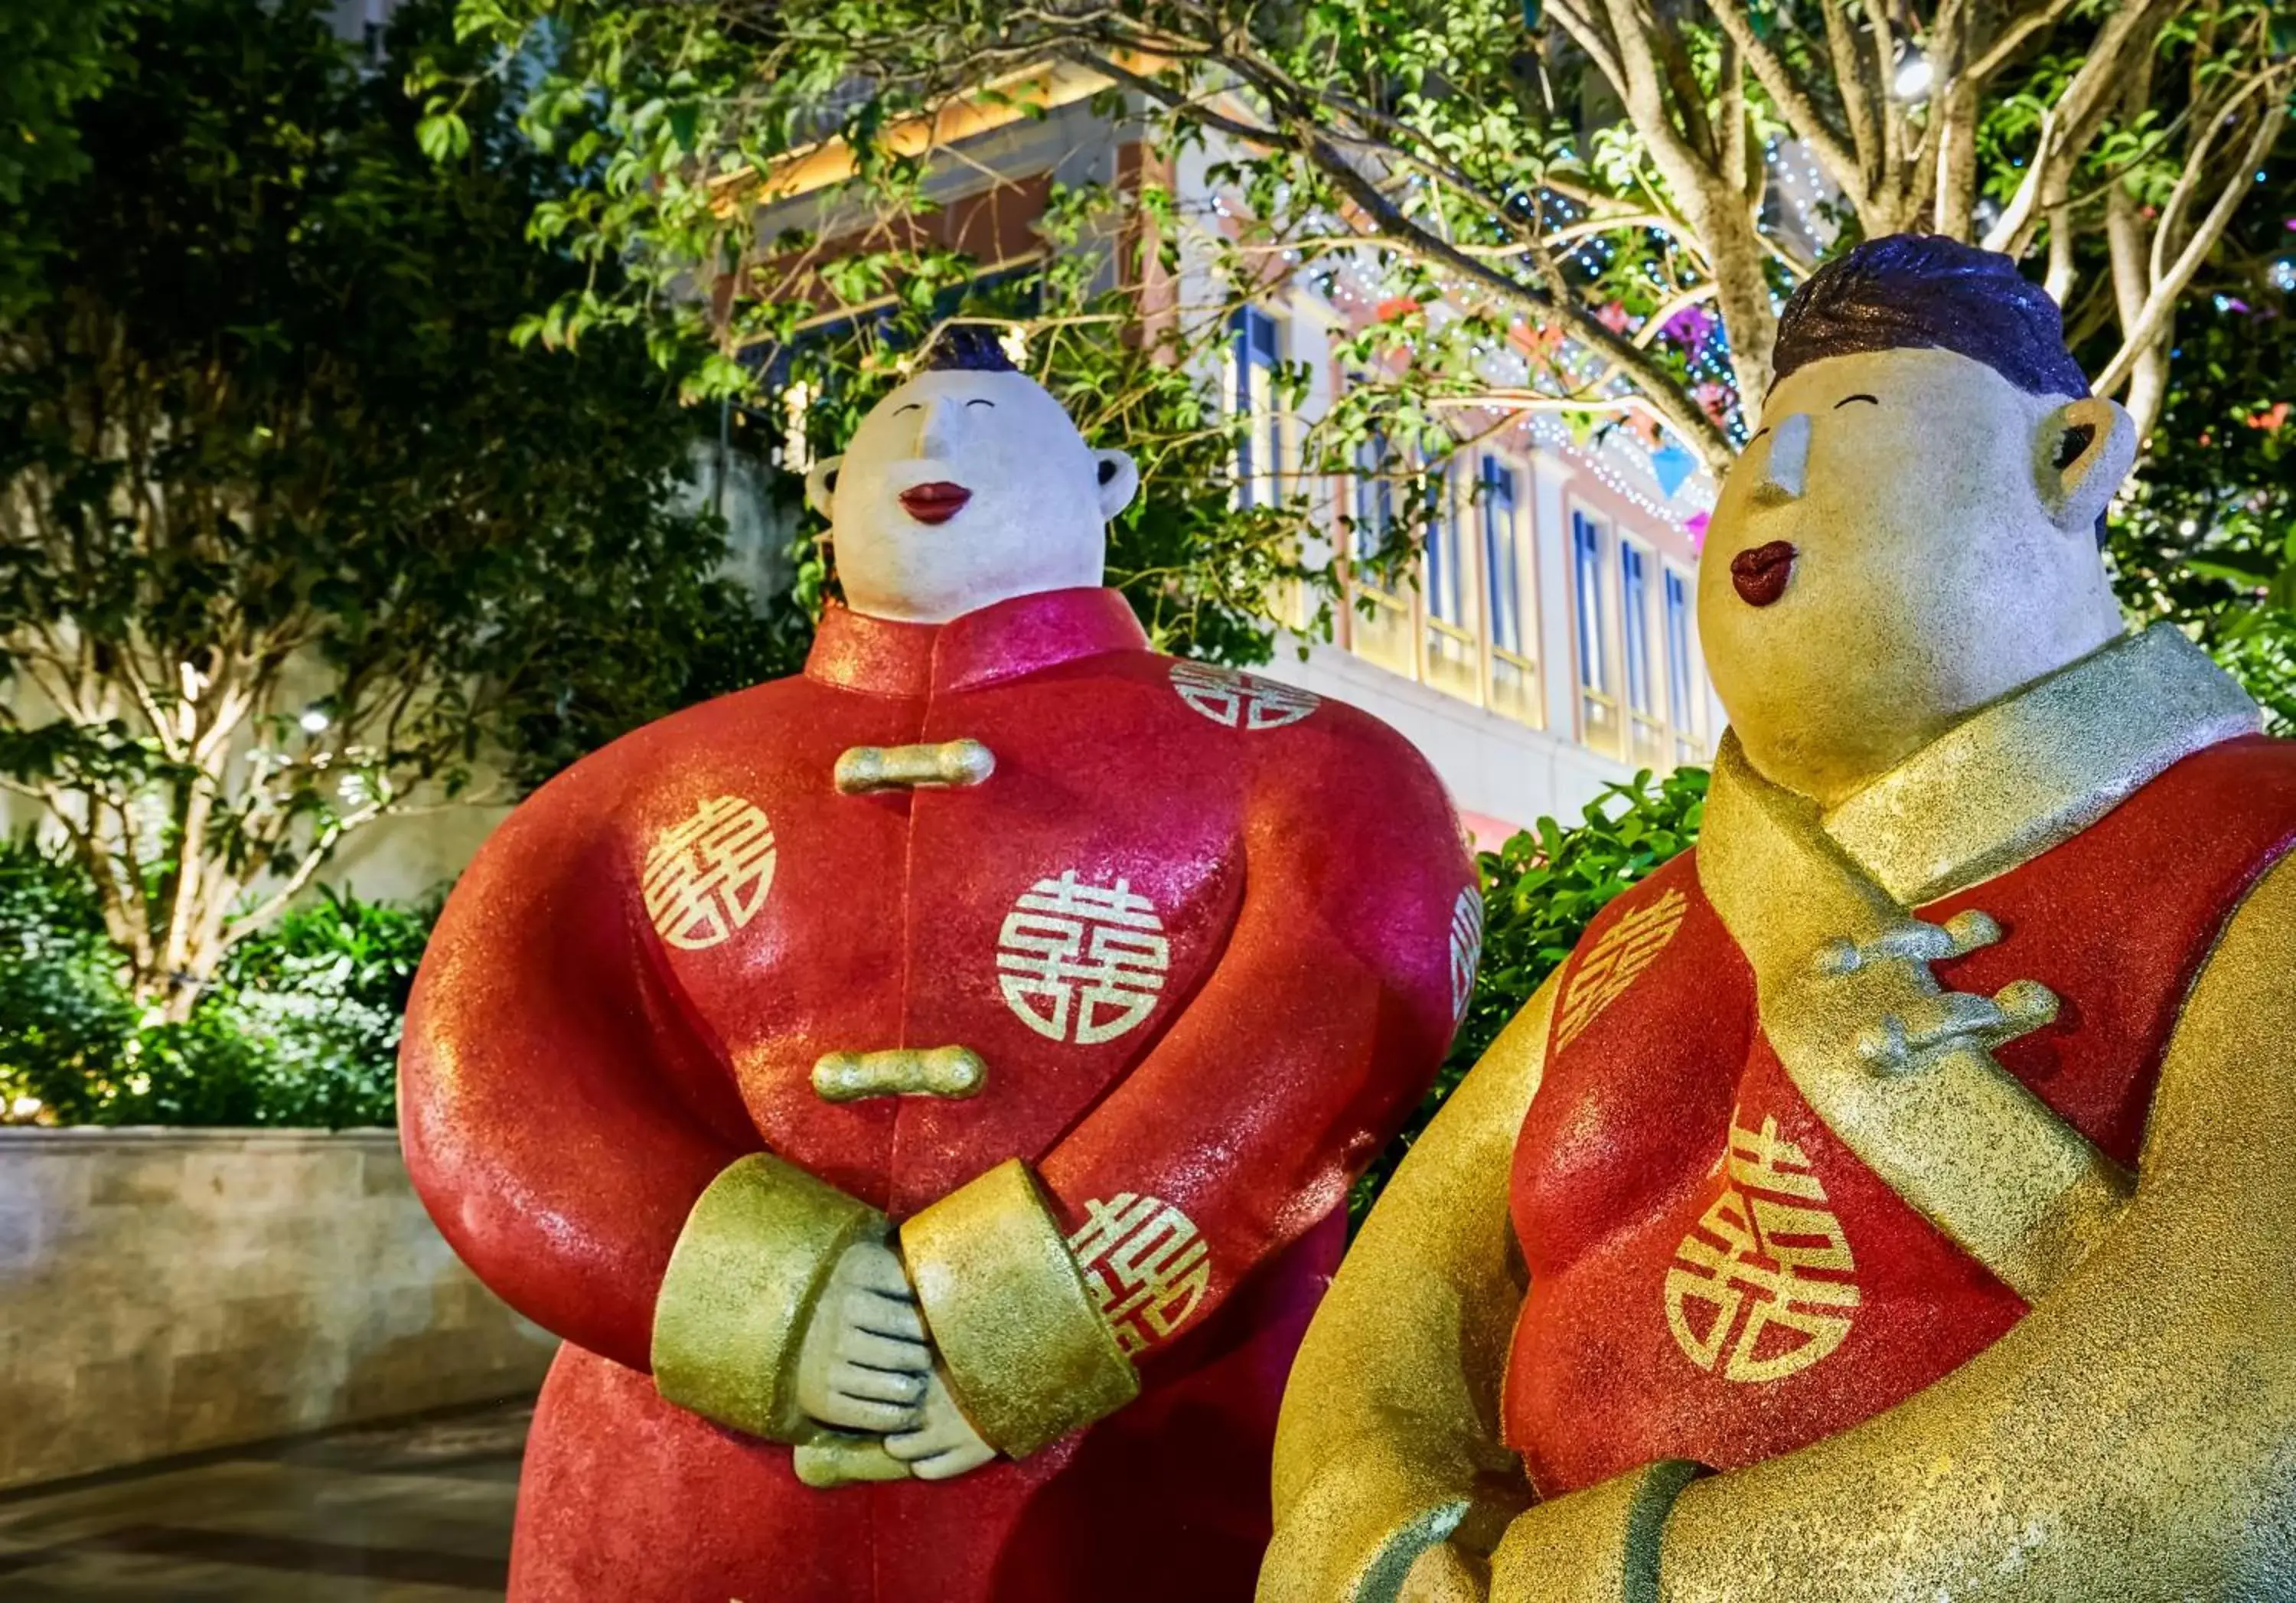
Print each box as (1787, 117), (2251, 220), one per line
(0, 0), (776, 1020)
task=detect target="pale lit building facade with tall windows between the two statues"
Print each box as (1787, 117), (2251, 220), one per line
(1226, 285), (1722, 847)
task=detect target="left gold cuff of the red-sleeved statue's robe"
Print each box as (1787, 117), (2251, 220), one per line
(652, 1153), (886, 1442)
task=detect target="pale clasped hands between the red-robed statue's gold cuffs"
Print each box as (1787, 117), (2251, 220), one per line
(797, 1242), (996, 1481)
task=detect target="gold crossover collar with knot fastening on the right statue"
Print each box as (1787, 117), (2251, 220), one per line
(1699, 625), (2257, 1302)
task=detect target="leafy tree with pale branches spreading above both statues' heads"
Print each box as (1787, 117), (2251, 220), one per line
(413, 0), (2296, 661)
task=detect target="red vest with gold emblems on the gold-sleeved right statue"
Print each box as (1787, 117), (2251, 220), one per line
(1504, 737), (2296, 1497)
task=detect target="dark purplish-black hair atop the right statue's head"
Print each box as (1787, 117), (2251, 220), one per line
(1773, 234), (2089, 397)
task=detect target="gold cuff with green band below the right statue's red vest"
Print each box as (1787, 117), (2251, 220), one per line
(1490, 1458), (1706, 1603)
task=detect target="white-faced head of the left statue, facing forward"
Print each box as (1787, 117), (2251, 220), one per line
(806, 324), (1139, 622)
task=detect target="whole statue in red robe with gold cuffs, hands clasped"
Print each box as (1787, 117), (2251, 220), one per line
(402, 331), (1481, 1603)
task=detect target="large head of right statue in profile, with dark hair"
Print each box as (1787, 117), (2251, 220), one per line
(1699, 234), (2138, 804)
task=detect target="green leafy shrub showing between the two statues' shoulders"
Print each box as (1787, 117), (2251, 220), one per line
(1348, 767), (1706, 1224)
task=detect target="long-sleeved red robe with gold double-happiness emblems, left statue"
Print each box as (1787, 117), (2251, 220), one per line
(402, 590), (1481, 1603)
